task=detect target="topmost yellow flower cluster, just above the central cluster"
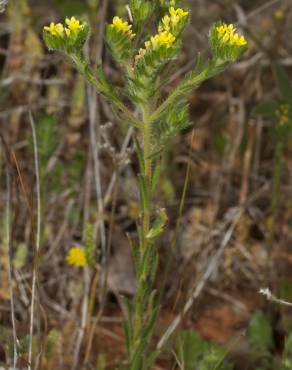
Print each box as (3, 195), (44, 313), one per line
(158, 6), (189, 36)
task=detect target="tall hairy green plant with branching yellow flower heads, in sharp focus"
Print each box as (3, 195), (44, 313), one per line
(44, 0), (246, 370)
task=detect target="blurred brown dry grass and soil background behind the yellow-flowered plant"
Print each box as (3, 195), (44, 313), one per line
(0, 0), (292, 370)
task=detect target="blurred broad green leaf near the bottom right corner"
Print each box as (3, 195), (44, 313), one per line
(247, 311), (274, 352)
